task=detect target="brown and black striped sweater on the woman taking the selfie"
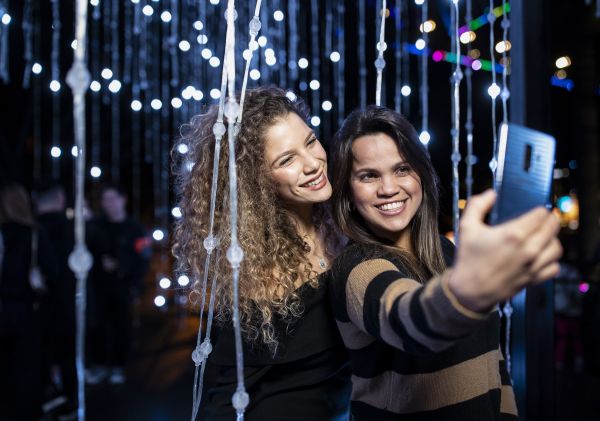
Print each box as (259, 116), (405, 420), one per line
(331, 238), (517, 421)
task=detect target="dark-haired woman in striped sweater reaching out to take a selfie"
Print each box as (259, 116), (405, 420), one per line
(331, 107), (561, 420)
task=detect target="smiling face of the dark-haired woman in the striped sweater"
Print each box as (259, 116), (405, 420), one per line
(350, 133), (423, 250)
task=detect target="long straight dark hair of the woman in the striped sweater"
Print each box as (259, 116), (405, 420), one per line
(331, 106), (446, 282)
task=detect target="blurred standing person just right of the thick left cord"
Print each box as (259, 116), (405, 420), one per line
(88, 185), (151, 384)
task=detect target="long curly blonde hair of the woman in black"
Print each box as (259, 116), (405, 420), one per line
(173, 88), (338, 352)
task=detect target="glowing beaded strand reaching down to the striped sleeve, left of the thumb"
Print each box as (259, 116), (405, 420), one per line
(450, 0), (462, 239)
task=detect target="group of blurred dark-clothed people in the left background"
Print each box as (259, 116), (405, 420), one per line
(0, 184), (151, 420)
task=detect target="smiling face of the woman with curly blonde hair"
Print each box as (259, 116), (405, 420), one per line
(265, 113), (331, 205)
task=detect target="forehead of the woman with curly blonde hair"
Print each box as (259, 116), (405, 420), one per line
(265, 113), (312, 160)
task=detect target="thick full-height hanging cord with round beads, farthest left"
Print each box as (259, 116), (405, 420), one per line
(67, 0), (92, 421)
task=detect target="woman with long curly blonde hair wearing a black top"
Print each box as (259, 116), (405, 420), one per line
(174, 88), (349, 420)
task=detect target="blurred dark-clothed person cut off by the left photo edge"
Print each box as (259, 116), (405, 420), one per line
(0, 184), (57, 421)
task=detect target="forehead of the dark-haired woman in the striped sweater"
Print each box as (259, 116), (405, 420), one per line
(352, 133), (405, 170)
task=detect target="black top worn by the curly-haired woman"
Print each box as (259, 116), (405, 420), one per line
(199, 272), (350, 421)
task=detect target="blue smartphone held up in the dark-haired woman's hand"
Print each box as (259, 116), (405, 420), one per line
(490, 124), (556, 224)
